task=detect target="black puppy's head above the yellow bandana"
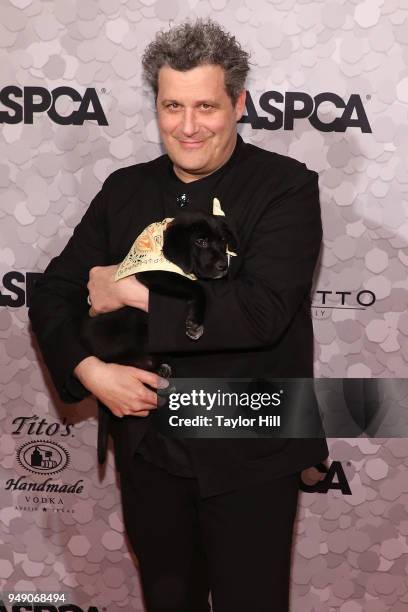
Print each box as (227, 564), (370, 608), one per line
(163, 211), (237, 279)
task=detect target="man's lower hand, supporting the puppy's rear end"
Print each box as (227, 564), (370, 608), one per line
(74, 357), (169, 417)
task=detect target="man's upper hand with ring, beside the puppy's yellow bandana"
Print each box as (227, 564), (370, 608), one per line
(87, 266), (149, 317)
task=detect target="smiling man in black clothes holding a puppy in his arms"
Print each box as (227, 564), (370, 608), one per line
(30, 20), (327, 612)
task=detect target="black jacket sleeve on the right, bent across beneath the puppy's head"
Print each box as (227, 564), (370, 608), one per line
(149, 165), (322, 352)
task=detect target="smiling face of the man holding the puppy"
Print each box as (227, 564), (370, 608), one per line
(156, 65), (245, 182)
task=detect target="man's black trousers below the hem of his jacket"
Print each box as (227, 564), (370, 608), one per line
(121, 456), (300, 612)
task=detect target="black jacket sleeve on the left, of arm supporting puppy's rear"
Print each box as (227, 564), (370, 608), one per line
(28, 173), (115, 402)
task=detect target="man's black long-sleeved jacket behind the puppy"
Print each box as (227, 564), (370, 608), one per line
(29, 137), (328, 495)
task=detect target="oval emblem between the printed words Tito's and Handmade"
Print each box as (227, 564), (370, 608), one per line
(17, 440), (70, 474)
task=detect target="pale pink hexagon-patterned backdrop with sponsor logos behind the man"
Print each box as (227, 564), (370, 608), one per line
(0, 0), (408, 612)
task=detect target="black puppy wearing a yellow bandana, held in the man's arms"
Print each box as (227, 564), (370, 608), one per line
(81, 211), (236, 463)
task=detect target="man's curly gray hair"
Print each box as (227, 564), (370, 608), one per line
(142, 19), (249, 105)
